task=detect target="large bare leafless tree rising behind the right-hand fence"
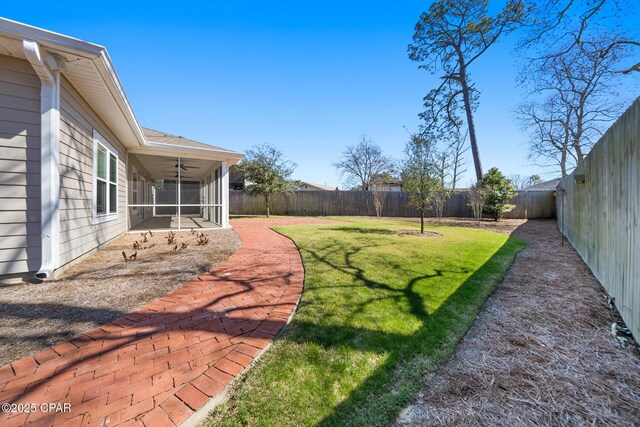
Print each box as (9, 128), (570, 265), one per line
(516, 0), (640, 176)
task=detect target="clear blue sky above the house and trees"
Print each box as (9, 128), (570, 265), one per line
(1, 0), (636, 186)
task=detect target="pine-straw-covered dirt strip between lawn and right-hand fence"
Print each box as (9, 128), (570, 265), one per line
(395, 220), (640, 426)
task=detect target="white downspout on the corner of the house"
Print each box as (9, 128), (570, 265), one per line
(22, 39), (65, 279)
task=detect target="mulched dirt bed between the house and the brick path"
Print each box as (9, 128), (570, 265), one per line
(0, 230), (241, 366)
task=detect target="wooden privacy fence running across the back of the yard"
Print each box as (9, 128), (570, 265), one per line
(229, 190), (556, 219)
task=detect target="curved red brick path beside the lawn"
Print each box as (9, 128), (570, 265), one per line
(0, 218), (330, 427)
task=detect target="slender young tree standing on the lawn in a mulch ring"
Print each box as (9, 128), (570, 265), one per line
(402, 135), (440, 233)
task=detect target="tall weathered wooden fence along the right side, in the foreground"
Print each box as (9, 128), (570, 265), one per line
(557, 98), (640, 339)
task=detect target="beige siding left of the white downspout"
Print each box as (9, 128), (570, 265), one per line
(0, 55), (41, 276)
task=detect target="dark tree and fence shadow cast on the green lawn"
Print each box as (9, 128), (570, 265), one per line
(283, 229), (524, 426)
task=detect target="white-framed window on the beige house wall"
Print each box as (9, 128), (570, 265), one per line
(93, 130), (118, 223)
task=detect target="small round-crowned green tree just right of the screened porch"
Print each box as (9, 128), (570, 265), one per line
(236, 144), (299, 218)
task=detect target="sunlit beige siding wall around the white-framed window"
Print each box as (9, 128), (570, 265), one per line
(60, 78), (127, 265)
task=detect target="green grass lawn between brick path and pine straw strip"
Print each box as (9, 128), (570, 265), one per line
(205, 218), (525, 426)
